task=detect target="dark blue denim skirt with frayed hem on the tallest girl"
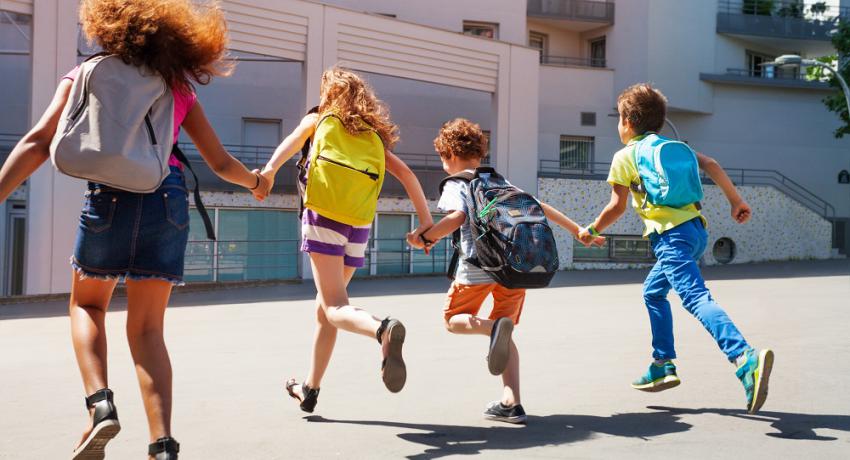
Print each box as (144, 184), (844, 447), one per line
(71, 166), (189, 285)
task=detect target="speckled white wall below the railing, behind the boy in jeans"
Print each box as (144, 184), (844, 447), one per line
(539, 179), (832, 269)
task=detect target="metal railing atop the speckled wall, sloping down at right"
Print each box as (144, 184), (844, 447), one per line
(538, 160), (835, 219)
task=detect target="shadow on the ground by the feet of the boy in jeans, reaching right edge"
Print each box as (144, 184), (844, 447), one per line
(647, 406), (850, 441)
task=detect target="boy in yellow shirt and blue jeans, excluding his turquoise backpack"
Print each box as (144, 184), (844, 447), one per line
(579, 84), (773, 414)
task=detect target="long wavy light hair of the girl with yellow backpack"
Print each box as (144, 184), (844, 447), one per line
(319, 67), (398, 150)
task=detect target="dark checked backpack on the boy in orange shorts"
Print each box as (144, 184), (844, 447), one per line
(440, 167), (558, 289)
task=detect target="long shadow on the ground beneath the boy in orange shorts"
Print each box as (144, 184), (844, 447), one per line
(304, 411), (691, 460)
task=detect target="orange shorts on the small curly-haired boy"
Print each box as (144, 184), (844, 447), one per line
(443, 283), (525, 324)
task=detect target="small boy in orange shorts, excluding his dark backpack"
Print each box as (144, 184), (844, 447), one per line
(407, 118), (604, 424)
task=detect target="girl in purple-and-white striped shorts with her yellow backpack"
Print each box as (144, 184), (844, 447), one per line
(262, 68), (433, 412)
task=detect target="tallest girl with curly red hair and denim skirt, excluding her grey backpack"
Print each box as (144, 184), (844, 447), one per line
(0, 0), (269, 460)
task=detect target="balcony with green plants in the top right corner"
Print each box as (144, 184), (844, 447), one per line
(717, 0), (850, 53)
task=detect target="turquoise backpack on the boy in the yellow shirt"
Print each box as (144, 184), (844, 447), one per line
(632, 133), (703, 208)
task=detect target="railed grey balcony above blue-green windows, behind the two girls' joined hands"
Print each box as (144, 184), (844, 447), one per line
(176, 143), (446, 199)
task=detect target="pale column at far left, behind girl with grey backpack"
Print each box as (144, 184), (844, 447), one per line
(25, 0), (78, 294)
